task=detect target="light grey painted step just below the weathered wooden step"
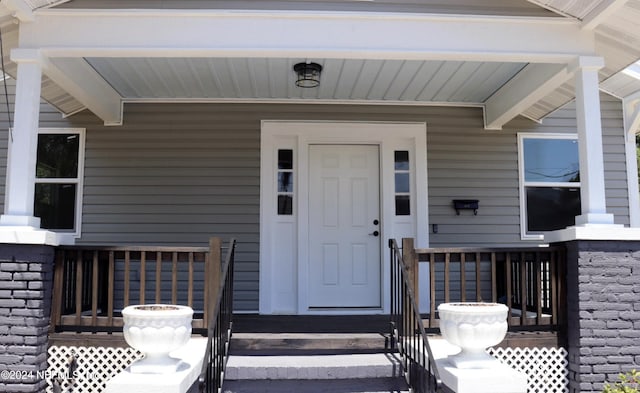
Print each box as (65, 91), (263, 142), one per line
(225, 353), (403, 380)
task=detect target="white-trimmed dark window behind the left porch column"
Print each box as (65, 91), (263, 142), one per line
(33, 128), (85, 236)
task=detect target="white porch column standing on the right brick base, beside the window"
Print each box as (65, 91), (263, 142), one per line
(575, 57), (613, 226)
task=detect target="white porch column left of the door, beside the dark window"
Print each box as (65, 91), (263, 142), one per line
(0, 50), (42, 228)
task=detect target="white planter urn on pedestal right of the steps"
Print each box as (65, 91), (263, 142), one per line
(438, 303), (509, 368)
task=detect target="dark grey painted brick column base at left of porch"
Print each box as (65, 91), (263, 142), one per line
(0, 244), (54, 392)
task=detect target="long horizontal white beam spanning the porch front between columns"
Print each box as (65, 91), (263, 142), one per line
(20, 9), (595, 63)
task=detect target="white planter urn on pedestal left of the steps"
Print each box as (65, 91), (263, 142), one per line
(122, 304), (193, 374)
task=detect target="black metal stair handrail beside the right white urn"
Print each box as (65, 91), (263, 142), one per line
(389, 239), (452, 393)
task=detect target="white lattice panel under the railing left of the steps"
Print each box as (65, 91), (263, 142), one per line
(46, 346), (143, 393)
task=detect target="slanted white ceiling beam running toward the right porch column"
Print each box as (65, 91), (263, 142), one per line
(484, 64), (571, 130)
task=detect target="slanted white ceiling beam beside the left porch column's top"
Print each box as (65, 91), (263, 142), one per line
(37, 58), (123, 126)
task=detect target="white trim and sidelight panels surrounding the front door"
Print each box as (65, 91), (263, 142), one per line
(260, 121), (429, 314)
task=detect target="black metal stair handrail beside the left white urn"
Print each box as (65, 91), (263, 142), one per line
(198, 239), (236, 393)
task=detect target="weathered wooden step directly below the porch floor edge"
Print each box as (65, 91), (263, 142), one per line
(230, 333), (388, 355)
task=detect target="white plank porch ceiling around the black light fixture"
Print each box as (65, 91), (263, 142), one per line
(78, 58), (525, 104)
